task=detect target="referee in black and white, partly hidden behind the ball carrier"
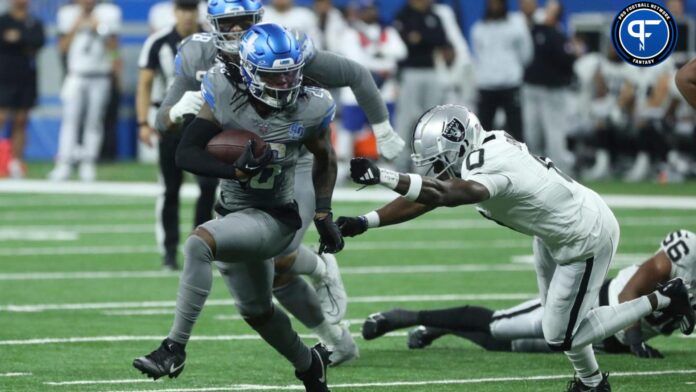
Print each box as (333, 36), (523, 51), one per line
(136, 0), (217, 270)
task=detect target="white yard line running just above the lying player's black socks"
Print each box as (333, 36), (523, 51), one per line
(0, 293), (537, 312)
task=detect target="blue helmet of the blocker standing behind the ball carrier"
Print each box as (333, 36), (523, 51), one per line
(208, 0), (263, 54)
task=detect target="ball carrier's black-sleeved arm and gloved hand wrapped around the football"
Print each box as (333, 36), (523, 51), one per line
(176, 104), (270, 180)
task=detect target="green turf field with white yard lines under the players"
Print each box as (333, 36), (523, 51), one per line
(0, 178), (696, 392)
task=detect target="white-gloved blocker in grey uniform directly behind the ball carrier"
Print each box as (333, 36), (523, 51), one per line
(157, 0), (404, 356)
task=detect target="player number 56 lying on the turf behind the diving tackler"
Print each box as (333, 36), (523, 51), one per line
(362, 230), (696, 358)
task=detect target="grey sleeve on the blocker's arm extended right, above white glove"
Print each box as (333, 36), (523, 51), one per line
(304, 51), (389, 124)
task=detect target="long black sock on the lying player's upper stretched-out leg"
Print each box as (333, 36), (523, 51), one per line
(416, 306), (493, 333)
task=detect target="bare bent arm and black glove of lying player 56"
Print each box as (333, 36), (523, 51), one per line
(619, 250), (672, 358)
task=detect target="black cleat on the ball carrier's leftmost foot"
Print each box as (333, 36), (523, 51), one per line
(133, 339), (186, 380)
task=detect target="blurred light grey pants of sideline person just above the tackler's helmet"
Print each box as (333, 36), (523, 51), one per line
(395, 68), (446, 172)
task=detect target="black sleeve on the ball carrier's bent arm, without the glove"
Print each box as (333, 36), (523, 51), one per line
(176, 117), (236, 180)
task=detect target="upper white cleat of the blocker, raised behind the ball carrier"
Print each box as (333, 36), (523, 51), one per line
(314, 253), (348, 324)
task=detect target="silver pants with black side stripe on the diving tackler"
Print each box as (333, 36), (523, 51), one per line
(533, 214), (619, 351)
